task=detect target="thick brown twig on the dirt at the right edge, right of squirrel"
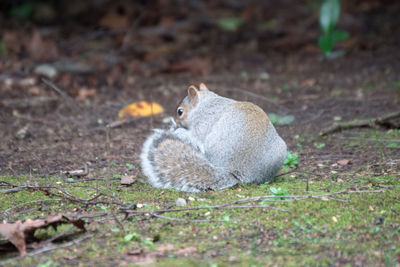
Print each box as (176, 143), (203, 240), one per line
(319, 111), (400, 136)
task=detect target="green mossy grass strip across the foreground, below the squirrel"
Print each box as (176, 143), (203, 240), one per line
(0, 173), (400, 266)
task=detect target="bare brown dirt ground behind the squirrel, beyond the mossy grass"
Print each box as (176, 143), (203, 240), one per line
(0, 1), (400, 266)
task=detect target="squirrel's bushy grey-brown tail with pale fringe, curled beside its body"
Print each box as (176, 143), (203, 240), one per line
(140, 130), (239, 192)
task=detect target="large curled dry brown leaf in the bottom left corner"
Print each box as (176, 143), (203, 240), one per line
(0, 214), (86, 256)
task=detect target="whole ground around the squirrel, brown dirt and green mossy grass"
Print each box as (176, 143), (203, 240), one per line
(0, 1), (400, 266)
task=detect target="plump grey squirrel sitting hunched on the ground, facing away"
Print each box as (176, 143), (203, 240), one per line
(140, 83), (287, 192)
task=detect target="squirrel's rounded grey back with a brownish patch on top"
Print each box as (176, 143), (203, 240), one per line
(204, 101), (286, 183)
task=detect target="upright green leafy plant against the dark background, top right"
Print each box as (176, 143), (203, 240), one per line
(318, 0), (349, 58)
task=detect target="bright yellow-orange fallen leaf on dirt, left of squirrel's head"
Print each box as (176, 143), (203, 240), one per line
(118, 101), (164, 118)
